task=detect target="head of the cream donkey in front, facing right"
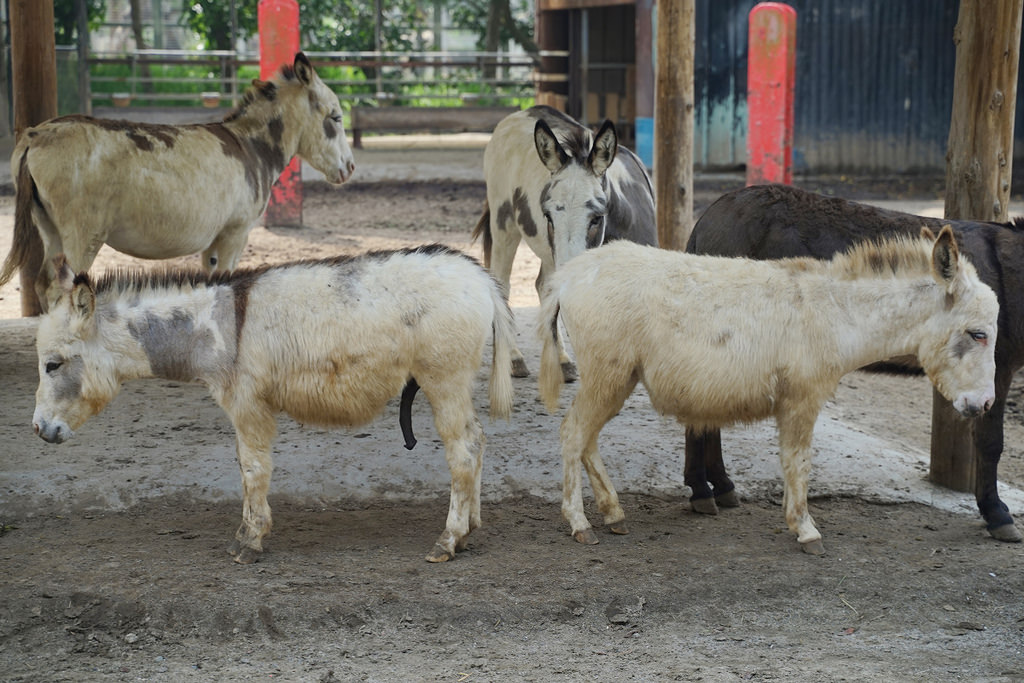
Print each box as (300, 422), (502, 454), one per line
(918, 225), (999, 417)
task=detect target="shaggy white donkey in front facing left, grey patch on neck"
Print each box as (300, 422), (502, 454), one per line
(33, 245), (515, 563)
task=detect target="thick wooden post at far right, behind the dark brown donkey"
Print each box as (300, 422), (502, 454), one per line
(929, 0), (1024, 492)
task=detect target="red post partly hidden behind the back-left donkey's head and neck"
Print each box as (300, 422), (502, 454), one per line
(257, 0), (302, 227)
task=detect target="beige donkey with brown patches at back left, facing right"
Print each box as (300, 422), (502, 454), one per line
(0, 52), (355, 310)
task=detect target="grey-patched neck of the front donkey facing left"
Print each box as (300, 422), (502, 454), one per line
(102, 286), (237, 384)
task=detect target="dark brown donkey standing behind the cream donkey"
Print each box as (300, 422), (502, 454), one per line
(685, 185), (1024, 543)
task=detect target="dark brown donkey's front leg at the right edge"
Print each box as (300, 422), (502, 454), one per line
(974, 372), (1021, 543)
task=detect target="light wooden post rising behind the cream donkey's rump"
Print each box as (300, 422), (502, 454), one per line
(654, 0), (695, 251)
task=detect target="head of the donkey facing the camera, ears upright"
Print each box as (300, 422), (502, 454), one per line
(534, 119), (618, 267)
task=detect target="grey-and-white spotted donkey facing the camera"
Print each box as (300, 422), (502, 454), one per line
(473, 105), (657, 382)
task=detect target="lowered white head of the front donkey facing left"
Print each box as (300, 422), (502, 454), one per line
(32, 255), (121, 443)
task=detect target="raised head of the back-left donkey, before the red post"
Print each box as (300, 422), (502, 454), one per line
(283, 52), (355, 184)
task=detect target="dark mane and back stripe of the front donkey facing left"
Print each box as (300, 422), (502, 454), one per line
(87, 244), (478, 296)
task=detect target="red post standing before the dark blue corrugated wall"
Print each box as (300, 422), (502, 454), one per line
(746, 2), (797, 185)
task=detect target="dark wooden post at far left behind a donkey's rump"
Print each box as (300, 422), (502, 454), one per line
(9, 0), (57, 316)
